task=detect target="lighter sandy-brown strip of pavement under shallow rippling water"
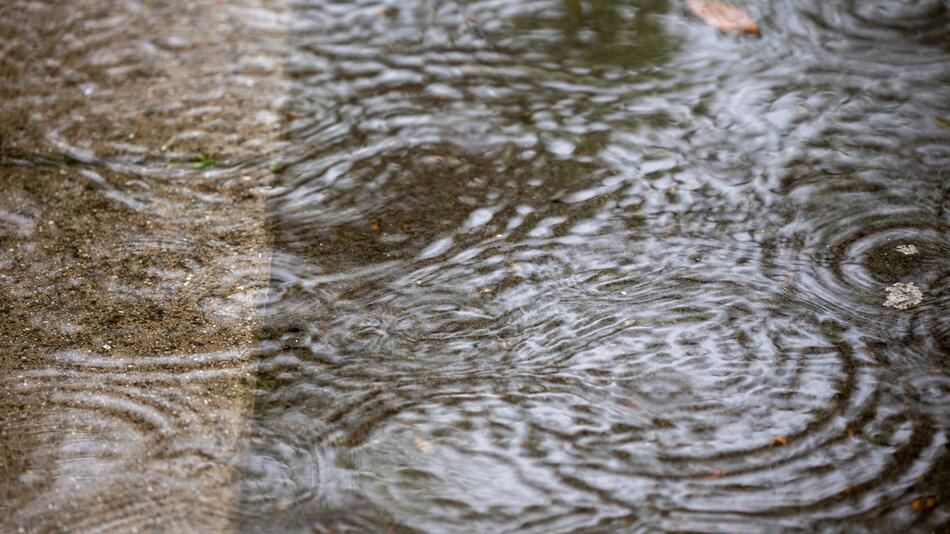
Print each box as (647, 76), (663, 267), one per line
(0, 0), (283, 532)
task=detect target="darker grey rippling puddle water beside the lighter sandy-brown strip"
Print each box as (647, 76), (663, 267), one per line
(242, 1), (950, 532)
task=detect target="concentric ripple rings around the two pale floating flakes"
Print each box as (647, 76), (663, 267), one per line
(767, 176), (950, 353)
